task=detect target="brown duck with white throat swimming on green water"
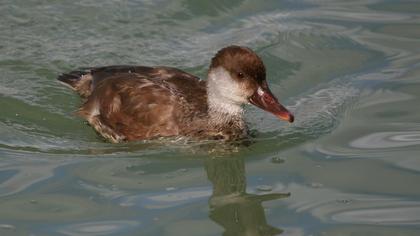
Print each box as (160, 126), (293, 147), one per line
(57, 45), (294, 143)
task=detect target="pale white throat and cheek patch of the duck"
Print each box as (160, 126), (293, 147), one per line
(207, 67), (247, 122)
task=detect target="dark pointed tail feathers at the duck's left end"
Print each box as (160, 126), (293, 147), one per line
(57, 70), (92, 97)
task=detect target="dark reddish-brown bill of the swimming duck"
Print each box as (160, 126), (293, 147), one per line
(249, 84), (295, 123)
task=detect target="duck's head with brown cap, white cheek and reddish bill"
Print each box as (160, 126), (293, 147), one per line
(207, 46), (294, 122)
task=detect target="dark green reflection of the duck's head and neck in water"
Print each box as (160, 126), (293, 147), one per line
(205, 158), (290, 236)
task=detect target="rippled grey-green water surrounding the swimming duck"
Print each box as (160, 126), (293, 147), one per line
(0, 0), (420, 236)
